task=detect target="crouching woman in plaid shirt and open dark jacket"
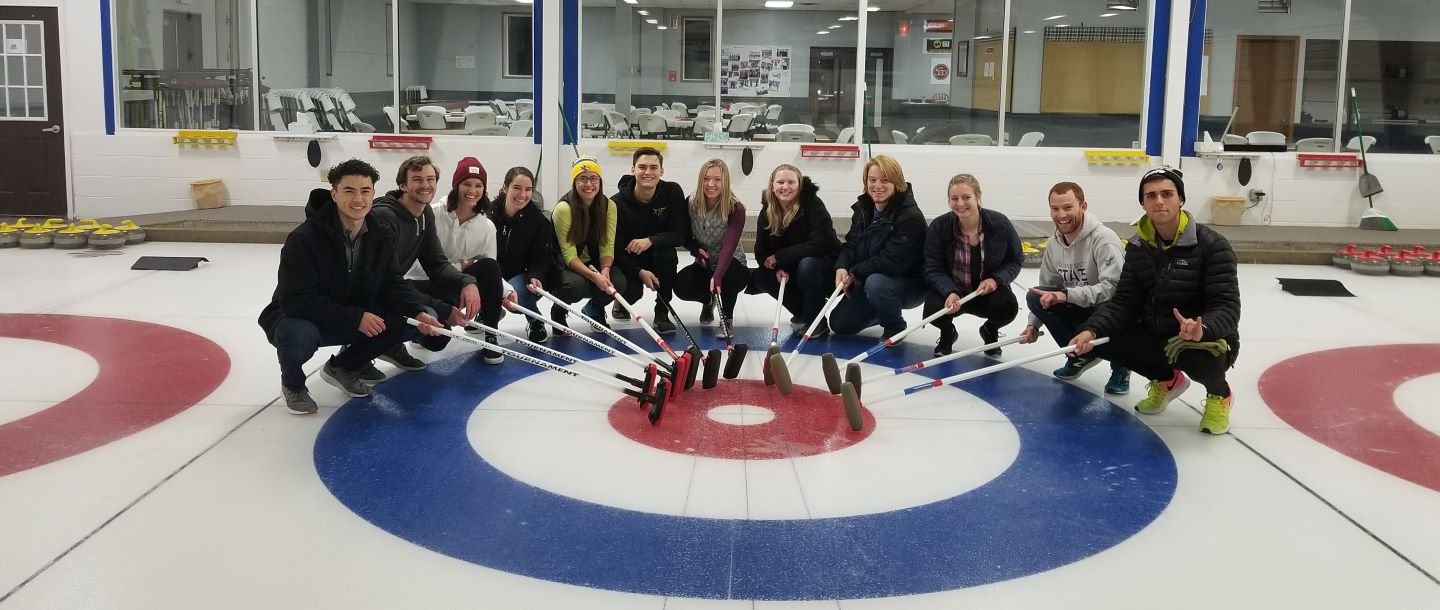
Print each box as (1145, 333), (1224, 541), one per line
(924, 174), (1025, 355)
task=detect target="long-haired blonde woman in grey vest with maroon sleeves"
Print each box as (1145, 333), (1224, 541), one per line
(675, 158), (750, 338)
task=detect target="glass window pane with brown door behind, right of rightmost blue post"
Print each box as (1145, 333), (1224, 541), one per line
(1198, 0), (1362, 151)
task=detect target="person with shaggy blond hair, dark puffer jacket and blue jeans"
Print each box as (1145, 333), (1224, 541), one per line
(829, 155), (926, 338)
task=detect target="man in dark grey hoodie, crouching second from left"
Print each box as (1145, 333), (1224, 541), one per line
(374, 157), (483, 366)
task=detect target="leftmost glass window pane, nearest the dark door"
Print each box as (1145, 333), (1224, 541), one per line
(115, 0), (256, 129)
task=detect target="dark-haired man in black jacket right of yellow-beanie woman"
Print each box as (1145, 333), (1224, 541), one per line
(612, 147), (690, 332)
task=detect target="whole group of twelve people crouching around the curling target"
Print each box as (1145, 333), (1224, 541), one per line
(261, 154), (1240, 434)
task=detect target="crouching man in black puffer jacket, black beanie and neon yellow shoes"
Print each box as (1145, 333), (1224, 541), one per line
(1070, 168), (1240, 434)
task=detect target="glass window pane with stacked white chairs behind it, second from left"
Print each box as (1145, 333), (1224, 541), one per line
(259, 0), (395, 132)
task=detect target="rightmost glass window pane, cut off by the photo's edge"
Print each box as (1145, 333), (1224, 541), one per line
(1342, 0), (1440, 154)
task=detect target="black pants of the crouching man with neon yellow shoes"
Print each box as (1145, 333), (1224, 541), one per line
(1092, 325), (1240, 396)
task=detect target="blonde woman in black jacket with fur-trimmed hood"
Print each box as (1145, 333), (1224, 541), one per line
(750, 164), (840, 333)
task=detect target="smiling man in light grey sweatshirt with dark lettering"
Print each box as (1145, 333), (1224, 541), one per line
(1021, 183), (1130, 394)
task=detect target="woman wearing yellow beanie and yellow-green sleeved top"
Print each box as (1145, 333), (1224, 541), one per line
(550, 157), (625, 325)
